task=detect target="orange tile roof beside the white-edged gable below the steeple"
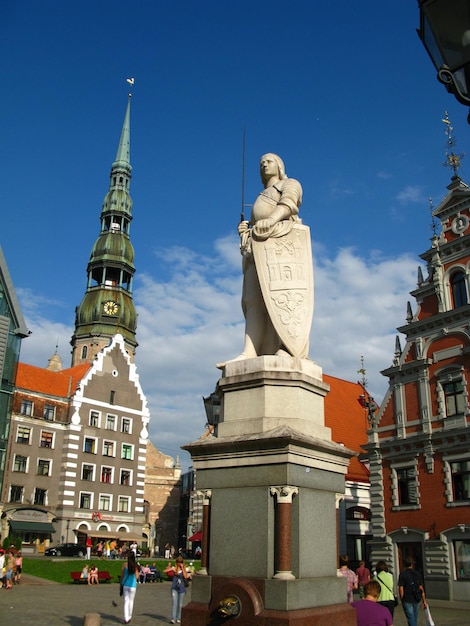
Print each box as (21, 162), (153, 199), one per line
(16, 363), (90, 398)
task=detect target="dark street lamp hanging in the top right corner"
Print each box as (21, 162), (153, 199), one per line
(418, 0), (470, 112)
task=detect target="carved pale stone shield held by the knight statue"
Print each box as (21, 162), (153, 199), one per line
(252, 224), (313, 359)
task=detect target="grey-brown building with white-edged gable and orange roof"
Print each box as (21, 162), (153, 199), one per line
(1, 335), (150, 551)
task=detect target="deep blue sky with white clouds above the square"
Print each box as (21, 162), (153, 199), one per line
(0, 0), (468, 464)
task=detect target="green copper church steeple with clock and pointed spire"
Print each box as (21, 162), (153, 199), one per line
(71, 95), (137, 365)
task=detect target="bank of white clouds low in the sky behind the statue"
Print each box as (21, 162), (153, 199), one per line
(19, 237), (418, 466)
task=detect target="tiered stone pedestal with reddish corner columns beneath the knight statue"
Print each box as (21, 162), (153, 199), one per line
(183, 356), (356, 626)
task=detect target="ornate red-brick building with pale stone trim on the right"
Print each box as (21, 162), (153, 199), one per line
(365, 118), (470, 600)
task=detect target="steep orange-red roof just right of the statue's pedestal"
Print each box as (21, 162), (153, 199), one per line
(323, 374), (369, 482)
